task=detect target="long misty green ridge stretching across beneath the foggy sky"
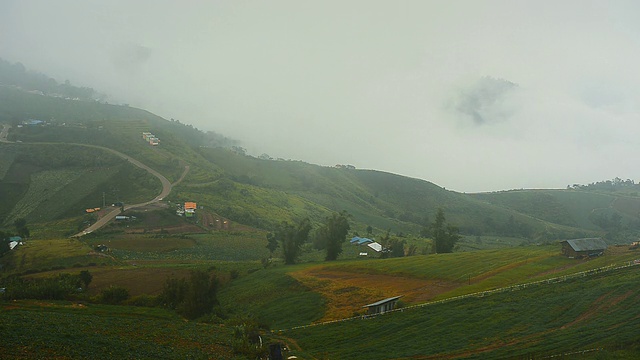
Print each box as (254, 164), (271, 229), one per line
(0, 82), (640, 242)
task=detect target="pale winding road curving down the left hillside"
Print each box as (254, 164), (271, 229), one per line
(0, 124), (189, 237)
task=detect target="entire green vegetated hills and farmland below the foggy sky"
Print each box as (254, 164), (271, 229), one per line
(0, 74), (640, 359)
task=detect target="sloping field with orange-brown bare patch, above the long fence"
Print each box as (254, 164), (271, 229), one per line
(216, 242), (638, 328)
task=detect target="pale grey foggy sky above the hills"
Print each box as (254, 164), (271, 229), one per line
(0, 0), (640, 192)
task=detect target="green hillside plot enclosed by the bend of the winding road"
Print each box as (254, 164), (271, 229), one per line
(0, 144), (160, 226)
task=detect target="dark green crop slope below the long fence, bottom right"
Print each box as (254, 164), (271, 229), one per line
(284, 267), (640, 359)
